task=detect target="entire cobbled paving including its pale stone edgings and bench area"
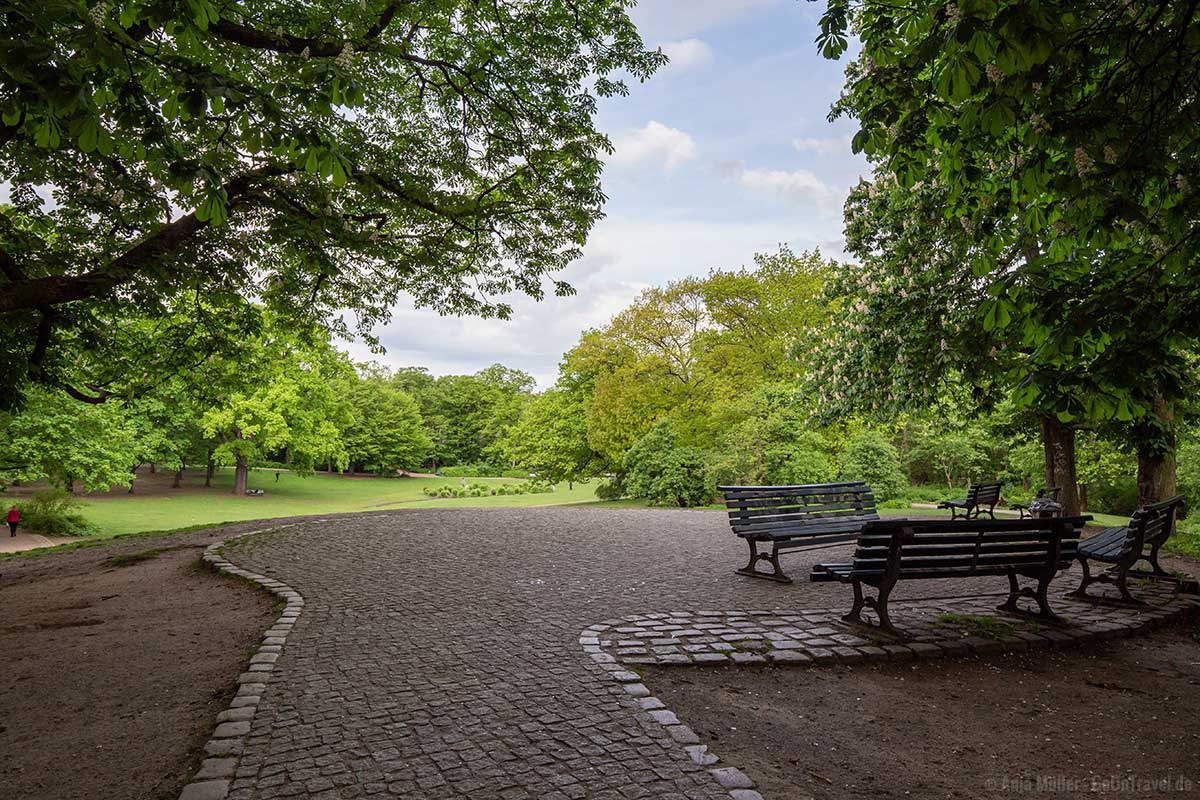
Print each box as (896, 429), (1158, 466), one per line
(180, 507), (1200, 800)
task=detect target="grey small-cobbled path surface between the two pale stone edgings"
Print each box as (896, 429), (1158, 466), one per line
(213, 507), (1180, 800)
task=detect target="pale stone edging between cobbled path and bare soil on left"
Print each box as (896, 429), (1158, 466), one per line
(179, 521), (312, 800)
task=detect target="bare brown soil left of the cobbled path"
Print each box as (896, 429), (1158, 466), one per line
(0, 525), (274, 800)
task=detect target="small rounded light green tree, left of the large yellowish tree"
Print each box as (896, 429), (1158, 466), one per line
(503, 389), (595, 483)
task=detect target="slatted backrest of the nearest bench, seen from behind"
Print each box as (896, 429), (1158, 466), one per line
(853, 517), (1091, 578)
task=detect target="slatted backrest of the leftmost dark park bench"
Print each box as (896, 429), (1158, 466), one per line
(716, 481), (880, 536)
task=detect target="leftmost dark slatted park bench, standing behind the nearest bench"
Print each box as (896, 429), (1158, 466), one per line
(716, 481), (880, 583)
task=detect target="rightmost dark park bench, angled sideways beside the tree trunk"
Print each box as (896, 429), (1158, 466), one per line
(1072, 494), (1184, 604)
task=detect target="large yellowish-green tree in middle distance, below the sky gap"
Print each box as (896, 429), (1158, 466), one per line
(560, 247), (830, 465)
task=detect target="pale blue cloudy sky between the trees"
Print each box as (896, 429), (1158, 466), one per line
(349, 0), (868, 389)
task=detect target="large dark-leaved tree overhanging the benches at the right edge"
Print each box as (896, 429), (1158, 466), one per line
(818, 0), (1200, 506)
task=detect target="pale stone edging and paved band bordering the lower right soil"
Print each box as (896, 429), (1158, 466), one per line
(580, 584), (1200, 800)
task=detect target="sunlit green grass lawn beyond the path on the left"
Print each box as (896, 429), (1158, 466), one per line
(82, 470), (595, 537)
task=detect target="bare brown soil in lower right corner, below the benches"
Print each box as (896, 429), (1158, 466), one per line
(644, 620), (1200, 800)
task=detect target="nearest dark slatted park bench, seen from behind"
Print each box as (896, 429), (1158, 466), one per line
(809, 517), (1091, 633)
